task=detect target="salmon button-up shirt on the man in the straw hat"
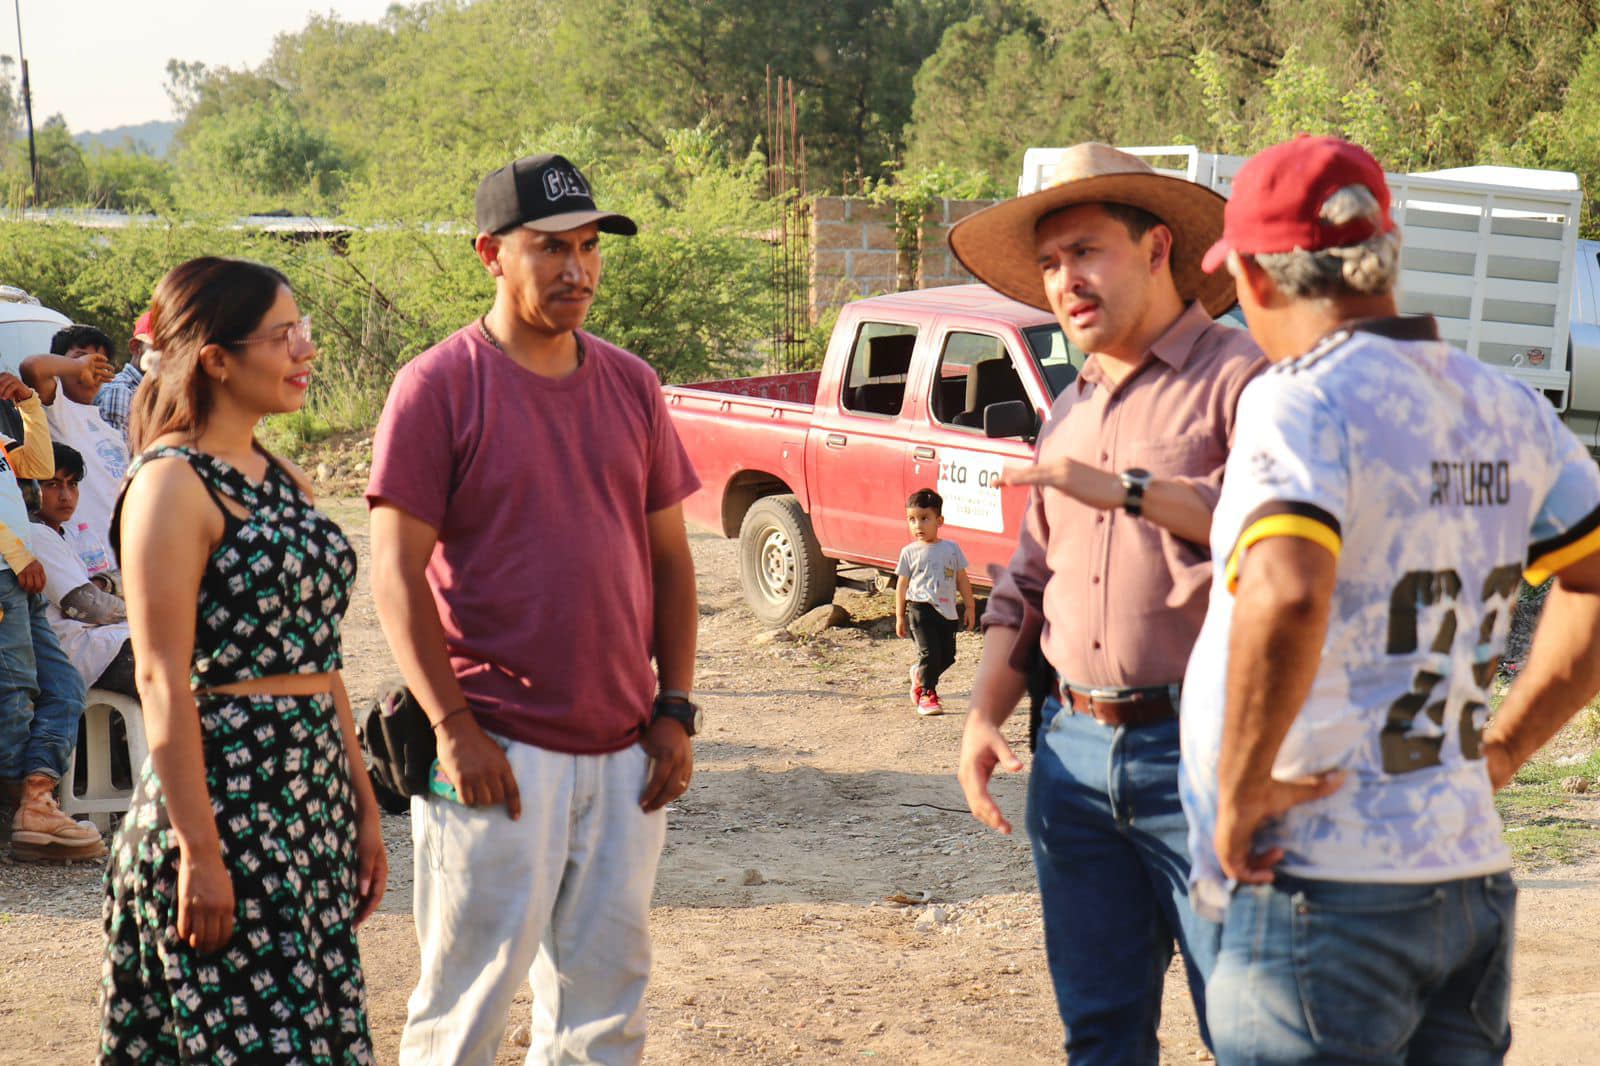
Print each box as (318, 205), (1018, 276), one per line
(984, 303), (1267, 688)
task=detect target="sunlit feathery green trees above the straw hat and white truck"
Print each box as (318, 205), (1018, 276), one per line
(906, 0), (1600, 229)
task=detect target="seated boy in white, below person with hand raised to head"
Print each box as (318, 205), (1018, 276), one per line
(29, 443), (139, 698)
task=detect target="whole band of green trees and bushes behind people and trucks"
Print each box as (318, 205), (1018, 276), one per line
(0, 0), (1600, 435)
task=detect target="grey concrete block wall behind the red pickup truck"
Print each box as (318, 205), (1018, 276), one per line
(811, 197), (994, 322)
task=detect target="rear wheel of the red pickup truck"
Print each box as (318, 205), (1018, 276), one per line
(739, 495), (835, 627)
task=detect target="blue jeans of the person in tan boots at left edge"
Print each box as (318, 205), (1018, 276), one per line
(0, 570), (86, 781)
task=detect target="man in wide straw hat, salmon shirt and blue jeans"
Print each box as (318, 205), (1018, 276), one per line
(950, 144), (1264, 1064)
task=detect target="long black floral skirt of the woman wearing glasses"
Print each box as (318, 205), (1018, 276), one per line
(99, 695), (373, 1066)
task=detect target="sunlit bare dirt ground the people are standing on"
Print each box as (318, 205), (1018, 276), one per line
(0, 501), (1600, 1066)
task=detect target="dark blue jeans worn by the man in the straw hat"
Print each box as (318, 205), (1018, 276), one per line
(1027, 696), (1219, 1066)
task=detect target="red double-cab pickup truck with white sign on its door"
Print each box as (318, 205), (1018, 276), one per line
(666, 285), (1083, 626)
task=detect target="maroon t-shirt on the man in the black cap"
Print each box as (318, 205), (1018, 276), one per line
(366, 325), (699, 754)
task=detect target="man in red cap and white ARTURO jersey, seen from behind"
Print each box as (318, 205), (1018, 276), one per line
(1181, 138), (1600, 1064)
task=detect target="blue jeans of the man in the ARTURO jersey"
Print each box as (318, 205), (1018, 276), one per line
(1206, 874), (1517, 1066)
